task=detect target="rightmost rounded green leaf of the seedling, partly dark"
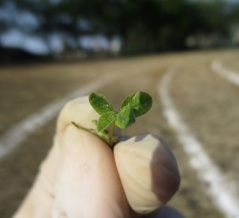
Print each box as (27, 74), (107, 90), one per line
(121, 92), (153, 117)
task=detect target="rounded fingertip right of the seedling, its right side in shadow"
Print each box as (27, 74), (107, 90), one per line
(114, 134), (180, 214)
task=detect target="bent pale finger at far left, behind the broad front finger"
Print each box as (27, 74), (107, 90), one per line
(14, 97), (98, 218)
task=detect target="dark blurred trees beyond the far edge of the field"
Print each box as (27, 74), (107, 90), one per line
(0, 0), (239, 54)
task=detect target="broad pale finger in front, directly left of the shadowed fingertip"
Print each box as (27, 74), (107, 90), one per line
(53, 125), (129, 218)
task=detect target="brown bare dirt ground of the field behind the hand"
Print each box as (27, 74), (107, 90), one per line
(0, 50), (239, 218)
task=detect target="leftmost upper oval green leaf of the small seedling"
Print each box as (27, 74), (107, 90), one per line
(89, 92), (115, 115)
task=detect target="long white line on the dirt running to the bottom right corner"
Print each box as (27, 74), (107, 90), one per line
(158, 69), (239, 218)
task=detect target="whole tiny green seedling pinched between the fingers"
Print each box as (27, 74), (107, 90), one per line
(72, 92), (153, 147)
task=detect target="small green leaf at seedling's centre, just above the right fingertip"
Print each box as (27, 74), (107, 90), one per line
(115, 105), (135, 129)
